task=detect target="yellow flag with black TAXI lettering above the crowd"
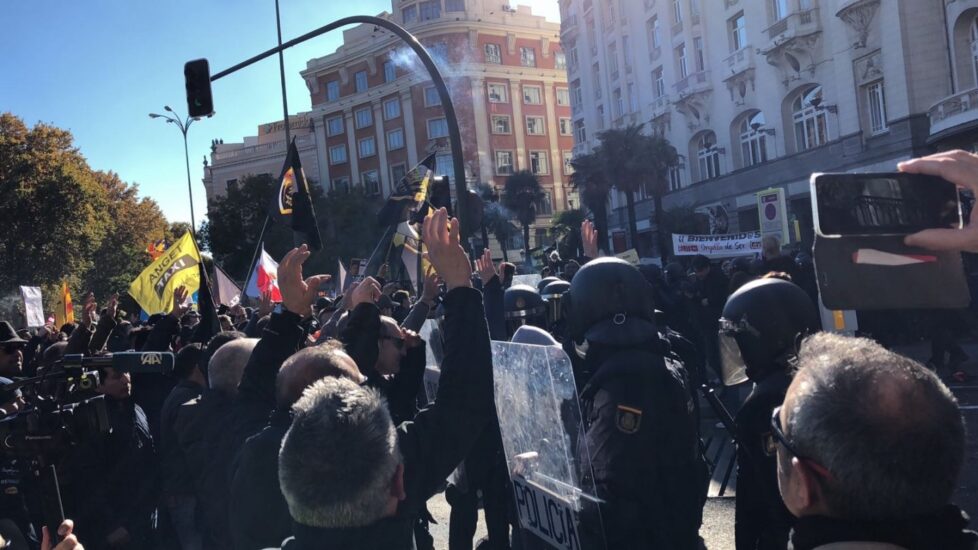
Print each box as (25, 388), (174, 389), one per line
(129, 231), (200, 314)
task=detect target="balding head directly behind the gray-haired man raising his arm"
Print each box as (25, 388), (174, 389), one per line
(275, 340), (364, 410)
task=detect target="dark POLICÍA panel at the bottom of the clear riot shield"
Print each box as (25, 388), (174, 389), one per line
(512, 476), (581, 550)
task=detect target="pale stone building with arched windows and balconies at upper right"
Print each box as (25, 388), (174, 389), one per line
(560, 0), (978, 256)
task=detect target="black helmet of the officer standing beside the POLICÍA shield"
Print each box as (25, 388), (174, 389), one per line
(562, 258), (657, 346)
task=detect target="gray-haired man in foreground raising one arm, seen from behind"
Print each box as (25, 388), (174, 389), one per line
(270, 208), (494, 550)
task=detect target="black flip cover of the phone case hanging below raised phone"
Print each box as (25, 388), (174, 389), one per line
(812, 235), (971, 310)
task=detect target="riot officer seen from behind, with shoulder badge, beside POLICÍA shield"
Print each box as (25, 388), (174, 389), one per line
(562, 258), (708, 550)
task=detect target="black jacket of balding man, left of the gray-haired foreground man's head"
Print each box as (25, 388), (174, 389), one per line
(229, 410), (292, 550)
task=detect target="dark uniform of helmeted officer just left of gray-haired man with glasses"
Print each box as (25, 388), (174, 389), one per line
(734, 371), (794, 550)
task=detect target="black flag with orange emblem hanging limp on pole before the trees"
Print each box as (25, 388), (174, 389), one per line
(270, 138), (323, 250)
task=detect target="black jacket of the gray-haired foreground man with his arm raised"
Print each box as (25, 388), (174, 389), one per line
(283, 288), (494, 550)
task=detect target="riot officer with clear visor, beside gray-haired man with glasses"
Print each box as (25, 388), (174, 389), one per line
(719, 279), (819, 550)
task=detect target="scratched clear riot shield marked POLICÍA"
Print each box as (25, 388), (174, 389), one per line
(492, 341), (605, 550)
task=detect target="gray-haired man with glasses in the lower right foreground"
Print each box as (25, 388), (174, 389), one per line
(767, 333), (978, 550)
